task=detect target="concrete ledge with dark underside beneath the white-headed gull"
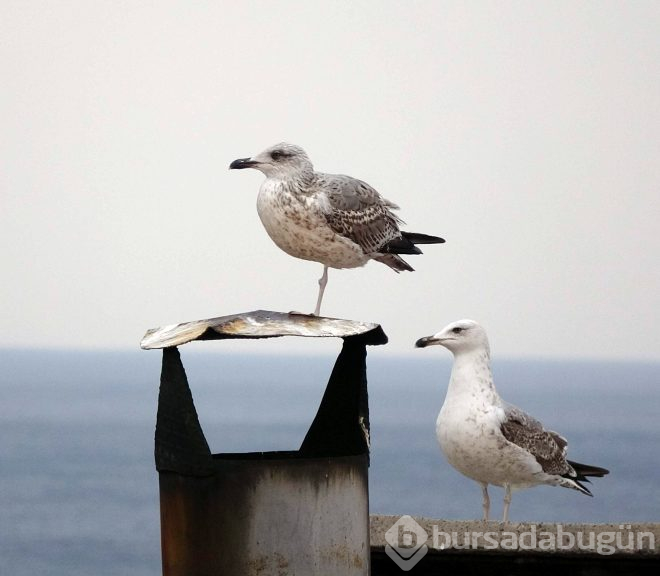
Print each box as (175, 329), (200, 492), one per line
(371, 515), (660, 576)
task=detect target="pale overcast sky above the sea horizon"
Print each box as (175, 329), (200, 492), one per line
(0, 0), (660, 360)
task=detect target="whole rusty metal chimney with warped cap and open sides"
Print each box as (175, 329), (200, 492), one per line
(141, 310), (387, 576)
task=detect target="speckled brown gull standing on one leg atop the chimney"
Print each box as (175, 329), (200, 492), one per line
(229, 142), (444, 316)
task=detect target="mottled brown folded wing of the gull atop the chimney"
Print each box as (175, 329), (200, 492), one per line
(314, 173), (403, 254)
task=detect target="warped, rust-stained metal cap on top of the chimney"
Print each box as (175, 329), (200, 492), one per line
(140, 310), (387, 350)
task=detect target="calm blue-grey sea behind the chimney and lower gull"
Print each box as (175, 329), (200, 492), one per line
(0, 349), (660, 576)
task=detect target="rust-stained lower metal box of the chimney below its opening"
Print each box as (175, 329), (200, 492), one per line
(160, 452), (370, 576)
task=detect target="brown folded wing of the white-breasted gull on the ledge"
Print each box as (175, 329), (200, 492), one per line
(500, 404), (575, 475)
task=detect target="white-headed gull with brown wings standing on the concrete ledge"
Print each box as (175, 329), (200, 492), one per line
(415, 320), (609, 522)
